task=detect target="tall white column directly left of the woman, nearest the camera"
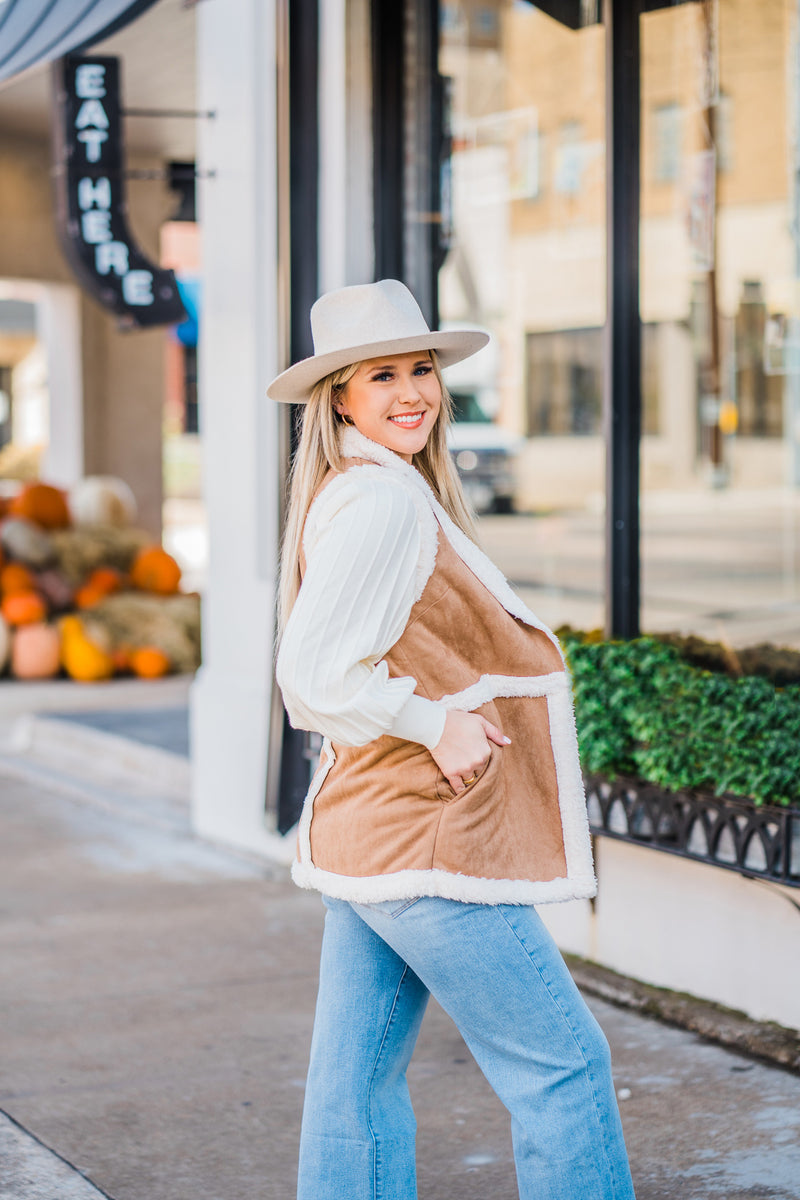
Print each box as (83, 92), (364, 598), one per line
(191, 0), (287, 853)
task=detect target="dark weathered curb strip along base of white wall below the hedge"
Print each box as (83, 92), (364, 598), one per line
(564, 954), (800, 1075)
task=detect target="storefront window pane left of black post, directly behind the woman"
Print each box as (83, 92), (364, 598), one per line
(439, 0), (606, 626)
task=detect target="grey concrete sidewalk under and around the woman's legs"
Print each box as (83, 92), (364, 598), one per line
(0, 691), (800, 1200)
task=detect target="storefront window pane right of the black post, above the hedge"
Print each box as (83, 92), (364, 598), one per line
(640, 0), (800, 650)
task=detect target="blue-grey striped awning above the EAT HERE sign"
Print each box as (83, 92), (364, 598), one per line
(0, 0), (156, 80)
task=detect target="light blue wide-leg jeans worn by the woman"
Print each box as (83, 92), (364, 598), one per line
(297, 898), (633, 1200)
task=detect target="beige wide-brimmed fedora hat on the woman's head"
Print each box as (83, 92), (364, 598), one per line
(266, 280), (489, 404)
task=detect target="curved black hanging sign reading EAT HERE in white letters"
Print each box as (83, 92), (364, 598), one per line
(54, 55), (186, 328)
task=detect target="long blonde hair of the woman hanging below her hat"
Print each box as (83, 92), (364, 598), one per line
(278, 350), (477, 635)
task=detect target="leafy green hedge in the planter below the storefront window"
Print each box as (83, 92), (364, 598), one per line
(561, 630), (800, 805)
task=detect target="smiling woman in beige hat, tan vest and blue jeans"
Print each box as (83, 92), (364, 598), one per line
(269, 280), (633, 1200)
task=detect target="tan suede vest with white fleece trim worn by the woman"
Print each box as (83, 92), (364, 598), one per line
(294, 453), (595, 902)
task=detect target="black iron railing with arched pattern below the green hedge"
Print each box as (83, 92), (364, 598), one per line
(585, 775), (800, 888)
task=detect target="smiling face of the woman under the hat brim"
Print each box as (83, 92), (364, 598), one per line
(335, 350), (441, 462)
